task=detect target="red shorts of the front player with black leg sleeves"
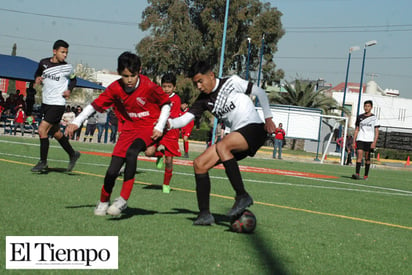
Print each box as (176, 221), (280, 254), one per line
(112, 128), (153, 158)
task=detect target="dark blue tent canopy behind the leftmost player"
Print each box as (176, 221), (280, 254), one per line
(0, 54), (105, 90)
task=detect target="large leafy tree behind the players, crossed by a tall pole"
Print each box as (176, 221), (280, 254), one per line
(136, 0), (284, 82)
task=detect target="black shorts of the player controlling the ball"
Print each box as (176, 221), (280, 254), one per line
(233, 123), (267, 160)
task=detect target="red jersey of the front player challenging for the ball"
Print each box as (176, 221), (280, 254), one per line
(92, 75), (170, 130)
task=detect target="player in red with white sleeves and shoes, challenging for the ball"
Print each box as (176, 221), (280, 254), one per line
(66, 52), (170, 216)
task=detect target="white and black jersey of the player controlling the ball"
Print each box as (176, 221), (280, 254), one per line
(189, 75), (264, 131)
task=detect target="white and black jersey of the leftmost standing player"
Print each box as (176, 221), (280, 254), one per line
(36, 58), (75, 106)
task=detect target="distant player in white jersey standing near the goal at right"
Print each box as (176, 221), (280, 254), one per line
(352, 100), (380, 180)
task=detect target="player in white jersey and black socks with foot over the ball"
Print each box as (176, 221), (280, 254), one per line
(168, 61), (276, 225)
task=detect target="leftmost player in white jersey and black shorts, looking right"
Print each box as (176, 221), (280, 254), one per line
(31, 40), (80, 172)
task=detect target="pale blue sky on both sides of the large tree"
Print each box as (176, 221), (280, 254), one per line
(0, 0), (412, 98)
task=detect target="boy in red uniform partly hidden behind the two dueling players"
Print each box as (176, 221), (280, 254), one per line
(146, 73), (182, 194)
